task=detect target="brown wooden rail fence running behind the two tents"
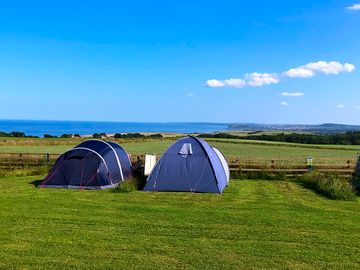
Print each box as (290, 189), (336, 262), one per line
(0, 153), (357, 177)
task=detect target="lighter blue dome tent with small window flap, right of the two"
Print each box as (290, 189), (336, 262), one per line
(144, 136), (229, 193)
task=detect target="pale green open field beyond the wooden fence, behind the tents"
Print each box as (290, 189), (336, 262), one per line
(0, 139), (360, 160)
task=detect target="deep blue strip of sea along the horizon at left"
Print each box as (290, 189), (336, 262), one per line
(0, 120), (229, 137)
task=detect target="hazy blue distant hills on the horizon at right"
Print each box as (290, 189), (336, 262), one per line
(228, 123), (360, 134)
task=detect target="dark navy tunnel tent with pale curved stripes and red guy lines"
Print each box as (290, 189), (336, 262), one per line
(40, 140), (132, 189)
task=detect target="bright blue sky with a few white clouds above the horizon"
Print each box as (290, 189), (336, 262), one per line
(0, 0), (360, 124)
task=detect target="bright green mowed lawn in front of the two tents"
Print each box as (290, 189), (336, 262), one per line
(0, 177), (360, 269)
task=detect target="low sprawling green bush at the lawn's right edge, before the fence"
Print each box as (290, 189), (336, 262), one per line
(300, 171), (357, 201)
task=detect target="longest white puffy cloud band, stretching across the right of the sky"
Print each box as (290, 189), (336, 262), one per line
(206, 61), (355, 88)
